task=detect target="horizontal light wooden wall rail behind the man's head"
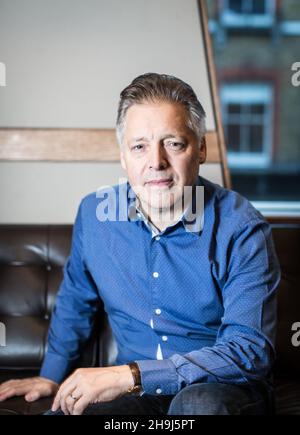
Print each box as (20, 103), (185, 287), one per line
(0, 128), (220, 163)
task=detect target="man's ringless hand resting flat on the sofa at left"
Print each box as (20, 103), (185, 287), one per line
(0, 377), (58, 402)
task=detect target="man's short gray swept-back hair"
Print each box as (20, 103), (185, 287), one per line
(116, 73), (206, 146)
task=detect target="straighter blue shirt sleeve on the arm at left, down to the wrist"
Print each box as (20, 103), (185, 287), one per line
(40, 203), (100, 383)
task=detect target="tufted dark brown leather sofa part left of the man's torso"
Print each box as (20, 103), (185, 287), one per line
(0, 225), (115, 414)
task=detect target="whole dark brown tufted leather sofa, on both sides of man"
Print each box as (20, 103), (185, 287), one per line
(0, 223), (300, 415)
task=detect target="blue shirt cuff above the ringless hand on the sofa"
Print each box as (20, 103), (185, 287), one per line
(40, 352), (71, 384)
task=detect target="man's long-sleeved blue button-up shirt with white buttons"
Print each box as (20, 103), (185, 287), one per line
(41, 176), (280, 394)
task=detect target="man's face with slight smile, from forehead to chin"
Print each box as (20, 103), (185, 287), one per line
(121, 101), (206, 210)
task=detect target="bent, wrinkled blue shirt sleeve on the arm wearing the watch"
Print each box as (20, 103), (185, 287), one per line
(137, 219), (280, 394)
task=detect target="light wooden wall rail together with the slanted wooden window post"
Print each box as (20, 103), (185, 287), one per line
(0, 0), (231, 188)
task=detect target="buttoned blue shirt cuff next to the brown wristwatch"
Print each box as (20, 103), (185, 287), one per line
(136, 359), (178, 395)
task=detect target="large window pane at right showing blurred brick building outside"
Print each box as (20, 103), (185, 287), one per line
(207, 0), (300, 202)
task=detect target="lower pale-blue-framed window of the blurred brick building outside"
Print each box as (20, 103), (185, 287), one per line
(221, 83), (273, 168)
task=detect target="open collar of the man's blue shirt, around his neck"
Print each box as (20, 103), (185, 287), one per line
(127, 176), (204, 237)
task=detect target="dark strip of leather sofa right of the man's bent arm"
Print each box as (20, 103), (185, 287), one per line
(272, 224), (300, 415)
